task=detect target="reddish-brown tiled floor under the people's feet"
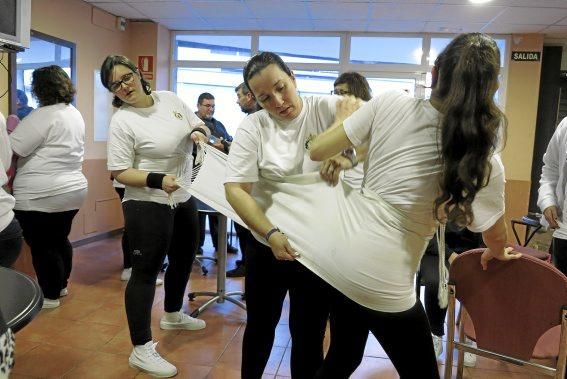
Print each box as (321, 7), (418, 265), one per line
(11, 233), (556, 379)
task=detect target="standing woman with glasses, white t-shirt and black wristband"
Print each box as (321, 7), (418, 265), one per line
(100, 55), (209, 377)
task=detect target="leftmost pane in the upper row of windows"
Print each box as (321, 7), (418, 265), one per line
(175, 34), (251, 62)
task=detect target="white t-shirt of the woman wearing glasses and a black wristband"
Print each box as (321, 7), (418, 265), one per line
(107, 91), (204, 204)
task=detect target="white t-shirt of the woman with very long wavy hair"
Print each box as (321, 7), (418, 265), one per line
(344, 91), (504, 232)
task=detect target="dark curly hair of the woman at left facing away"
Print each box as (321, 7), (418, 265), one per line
(32, 65), (75, 107)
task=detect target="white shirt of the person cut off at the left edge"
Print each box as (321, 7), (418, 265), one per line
(0, 113), (16, 231)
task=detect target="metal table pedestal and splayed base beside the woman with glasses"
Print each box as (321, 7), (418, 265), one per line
(189, 210), (246, 317)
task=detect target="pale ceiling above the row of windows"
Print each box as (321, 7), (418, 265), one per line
(85, 0), (567, 38)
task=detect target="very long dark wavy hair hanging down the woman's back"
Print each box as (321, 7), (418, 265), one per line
(432, 33), (506, 226)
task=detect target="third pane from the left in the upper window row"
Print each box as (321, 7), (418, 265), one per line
(350, 37), (423, 64)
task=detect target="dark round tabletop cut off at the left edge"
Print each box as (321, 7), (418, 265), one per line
(0, 267), (43, 332)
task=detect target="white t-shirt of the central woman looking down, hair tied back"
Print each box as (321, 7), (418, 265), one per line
(225, 96), (339, 183)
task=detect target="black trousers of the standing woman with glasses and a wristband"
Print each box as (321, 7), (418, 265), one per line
(122, 198), (199, 345)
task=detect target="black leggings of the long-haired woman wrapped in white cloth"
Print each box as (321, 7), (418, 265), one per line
(316, 290), (439, 379)
